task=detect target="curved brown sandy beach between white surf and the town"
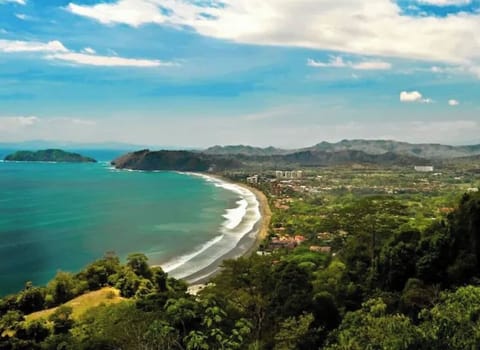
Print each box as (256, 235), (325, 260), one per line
(176, 173), (271, 288)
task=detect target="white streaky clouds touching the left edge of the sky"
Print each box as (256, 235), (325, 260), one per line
(0, 40), (176, 68)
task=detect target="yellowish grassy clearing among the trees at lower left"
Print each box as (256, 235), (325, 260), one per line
(25, 287), (126, 322)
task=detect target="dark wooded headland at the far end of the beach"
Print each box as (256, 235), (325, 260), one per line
(112, 149), (242, 172)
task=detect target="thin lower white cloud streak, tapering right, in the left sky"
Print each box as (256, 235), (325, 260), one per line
(47, 52), (175, 67)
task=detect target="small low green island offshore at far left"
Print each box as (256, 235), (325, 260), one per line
(5, 149), (97, 163)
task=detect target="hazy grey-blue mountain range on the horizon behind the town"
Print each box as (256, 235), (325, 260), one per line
(204, 140), (480, 159)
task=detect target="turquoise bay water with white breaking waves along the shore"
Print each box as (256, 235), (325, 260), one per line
(0, 150), (259, 295)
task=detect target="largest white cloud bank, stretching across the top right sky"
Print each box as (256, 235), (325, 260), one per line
(67, 0), (480, 73)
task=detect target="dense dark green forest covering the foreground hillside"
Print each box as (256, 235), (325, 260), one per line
(0, 193), (480, 350)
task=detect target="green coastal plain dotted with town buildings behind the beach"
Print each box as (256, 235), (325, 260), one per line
(232, 165), (480, 256)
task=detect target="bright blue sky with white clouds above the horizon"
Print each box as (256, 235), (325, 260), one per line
(0, 0), (480, 148)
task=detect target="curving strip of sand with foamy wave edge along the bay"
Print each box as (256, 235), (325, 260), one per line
(171, 173), (271, 284)
